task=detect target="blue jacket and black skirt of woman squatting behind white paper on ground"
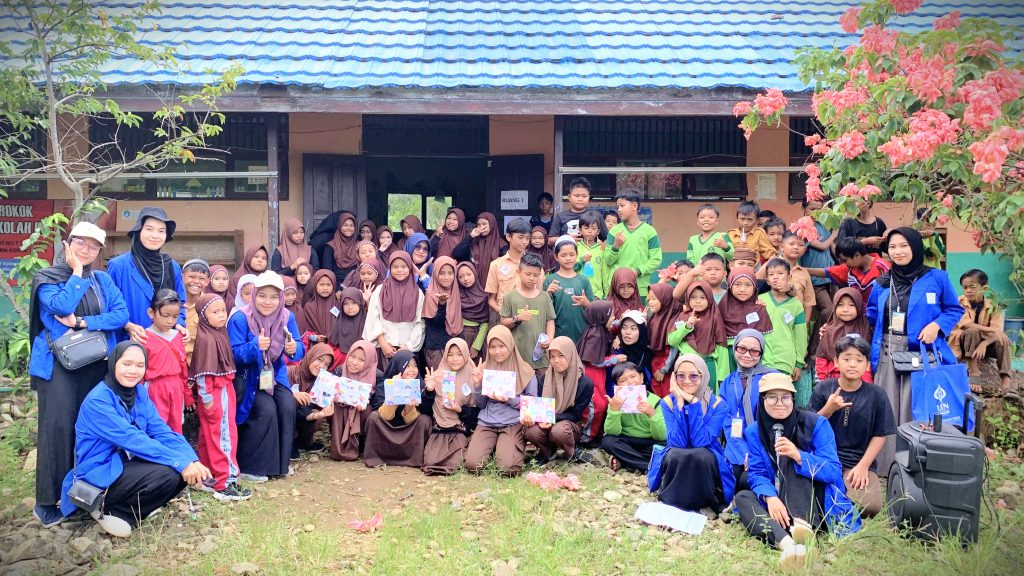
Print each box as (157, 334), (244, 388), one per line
(651, 395), (735, 510)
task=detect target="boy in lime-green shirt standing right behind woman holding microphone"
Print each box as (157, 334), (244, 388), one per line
(758, 258), (807, 382)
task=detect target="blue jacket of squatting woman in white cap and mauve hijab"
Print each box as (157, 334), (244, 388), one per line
(233, 313), (306, 424)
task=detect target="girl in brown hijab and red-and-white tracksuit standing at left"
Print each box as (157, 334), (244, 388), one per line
(188, 294), (252, 500)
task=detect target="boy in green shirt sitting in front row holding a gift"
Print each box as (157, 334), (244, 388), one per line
(601, 362), (669, 474)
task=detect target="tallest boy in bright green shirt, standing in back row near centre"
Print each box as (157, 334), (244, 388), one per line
(604, 191), (662, 299)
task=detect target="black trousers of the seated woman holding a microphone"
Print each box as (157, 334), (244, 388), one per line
(736, 462), (825, 546)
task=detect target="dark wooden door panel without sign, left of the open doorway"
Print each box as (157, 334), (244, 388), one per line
(302, 154), (367, 231)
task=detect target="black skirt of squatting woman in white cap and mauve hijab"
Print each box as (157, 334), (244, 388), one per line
(239, 384), (296, 476)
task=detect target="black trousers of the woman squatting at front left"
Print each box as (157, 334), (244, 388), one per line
(103, 458), (185, 526)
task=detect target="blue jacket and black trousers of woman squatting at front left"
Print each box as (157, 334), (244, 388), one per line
(60, 382), (193, 526)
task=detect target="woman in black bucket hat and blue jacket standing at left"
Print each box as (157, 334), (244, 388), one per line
(106, 206), (190, 342)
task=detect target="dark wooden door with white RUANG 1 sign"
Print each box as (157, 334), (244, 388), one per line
(486, 154), (544, 228)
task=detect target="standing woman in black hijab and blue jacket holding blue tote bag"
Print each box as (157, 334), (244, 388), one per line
(865, 228), (967, 477)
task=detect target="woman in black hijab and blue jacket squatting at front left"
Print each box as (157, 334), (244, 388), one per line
(60, 341), (210, 538)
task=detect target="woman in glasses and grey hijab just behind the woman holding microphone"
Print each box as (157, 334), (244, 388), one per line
(718, 328), (776, 490)
